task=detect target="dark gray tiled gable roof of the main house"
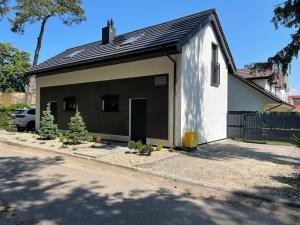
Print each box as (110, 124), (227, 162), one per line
(28, 10), (235, 74)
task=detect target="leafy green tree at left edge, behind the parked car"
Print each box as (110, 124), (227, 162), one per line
(0, 43), (30, 92)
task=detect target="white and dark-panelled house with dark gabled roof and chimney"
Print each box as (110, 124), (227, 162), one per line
(28, 10), (292, 146)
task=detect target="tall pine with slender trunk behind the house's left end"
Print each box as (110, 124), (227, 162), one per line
(8, 0), (86, 103)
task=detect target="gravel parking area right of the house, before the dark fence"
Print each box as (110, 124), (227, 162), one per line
(138, 140), (300, 202)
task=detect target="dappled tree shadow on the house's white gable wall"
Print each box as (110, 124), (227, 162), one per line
(182, 31), (209, 143)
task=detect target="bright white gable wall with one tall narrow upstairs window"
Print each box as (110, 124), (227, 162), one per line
(176, 24), (228, 145)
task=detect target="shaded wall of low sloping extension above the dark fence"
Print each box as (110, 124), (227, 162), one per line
(228, 75), (276, 112)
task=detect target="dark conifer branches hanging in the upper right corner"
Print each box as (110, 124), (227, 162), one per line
(252, 0), (300, 73)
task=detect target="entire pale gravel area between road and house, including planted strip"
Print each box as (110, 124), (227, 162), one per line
(0, 128), (300, 202)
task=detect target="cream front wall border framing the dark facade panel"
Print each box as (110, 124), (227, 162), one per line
(36, 55), (178, 146)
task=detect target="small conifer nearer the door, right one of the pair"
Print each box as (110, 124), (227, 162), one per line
(66, 112), (87, 144)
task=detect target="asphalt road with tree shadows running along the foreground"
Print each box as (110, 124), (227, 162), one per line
(0, 142), (300, 225)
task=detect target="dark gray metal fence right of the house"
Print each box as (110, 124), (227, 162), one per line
(227, 112), (300, 143)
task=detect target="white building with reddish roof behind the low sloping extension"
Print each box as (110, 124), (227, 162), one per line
(237, 69), (289, 102)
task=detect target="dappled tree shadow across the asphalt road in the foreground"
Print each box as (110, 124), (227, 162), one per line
(0, 148), (299, 225)
